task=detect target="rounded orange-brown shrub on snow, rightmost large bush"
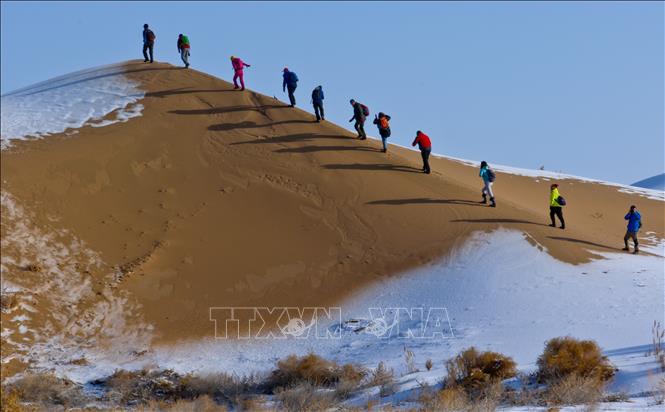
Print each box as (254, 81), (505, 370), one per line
(538, 336), (614, 384)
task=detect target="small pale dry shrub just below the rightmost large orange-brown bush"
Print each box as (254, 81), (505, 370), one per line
(544, 374), (604, 405)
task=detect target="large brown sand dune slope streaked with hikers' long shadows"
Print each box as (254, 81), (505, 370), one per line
(1, 62), (665, 374)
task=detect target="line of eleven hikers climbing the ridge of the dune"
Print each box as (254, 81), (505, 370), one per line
(143, 24), (642, 254)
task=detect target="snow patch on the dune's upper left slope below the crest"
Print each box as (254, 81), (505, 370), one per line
(0, 64), (144, 149)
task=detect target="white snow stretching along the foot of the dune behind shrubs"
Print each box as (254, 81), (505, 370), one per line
(37, 230), (665, 408)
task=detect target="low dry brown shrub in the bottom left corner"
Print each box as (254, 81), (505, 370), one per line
(3, 373), (90, 411)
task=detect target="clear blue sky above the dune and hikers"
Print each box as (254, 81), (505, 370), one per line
(1, 1), (665, 183)
